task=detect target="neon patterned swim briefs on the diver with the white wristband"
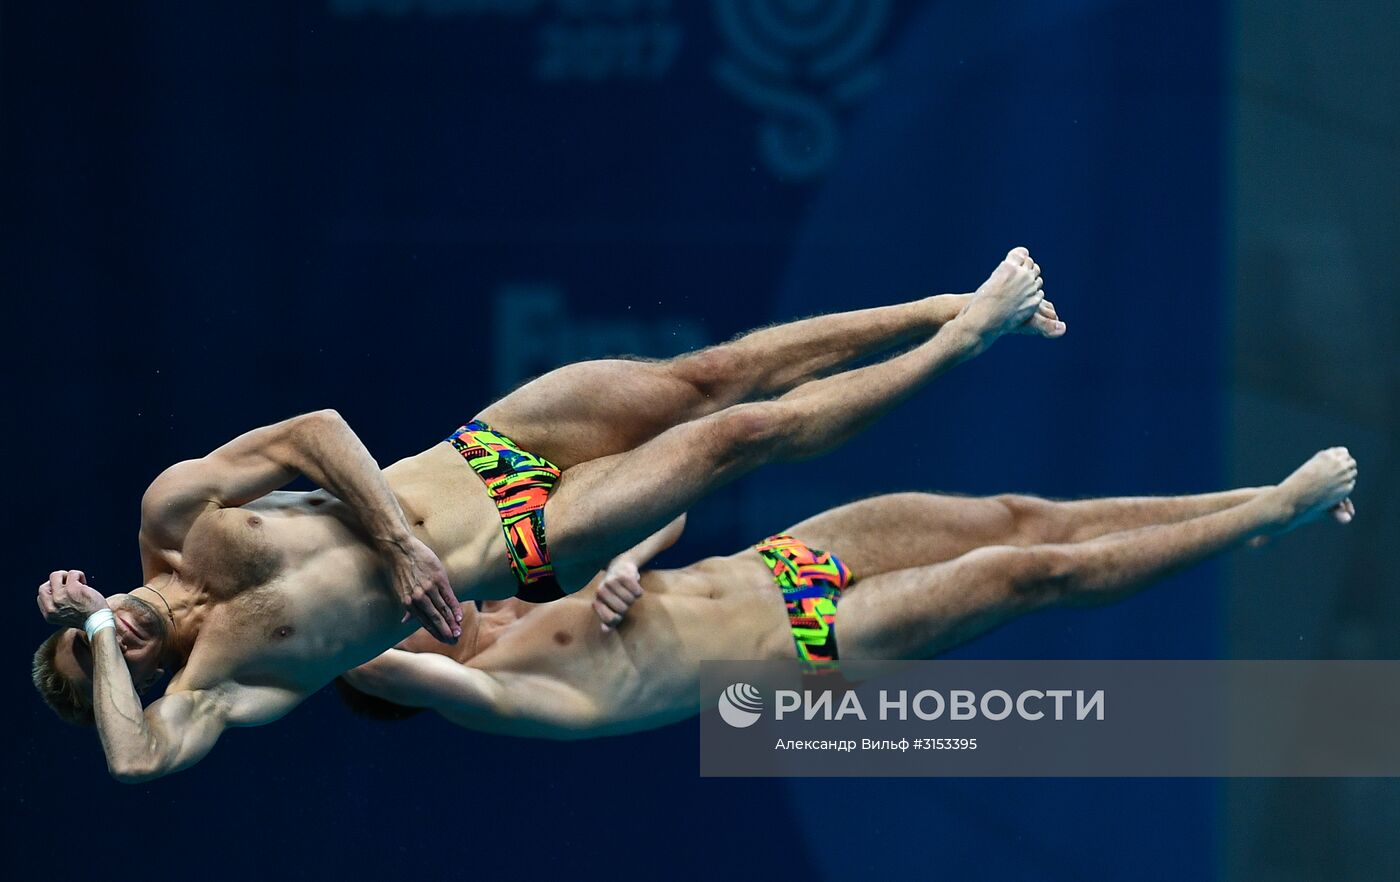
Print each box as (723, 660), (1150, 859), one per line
(447, 420), (564, 603)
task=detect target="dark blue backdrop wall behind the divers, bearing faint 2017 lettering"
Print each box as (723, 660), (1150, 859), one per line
(0, 0), (1226, 879)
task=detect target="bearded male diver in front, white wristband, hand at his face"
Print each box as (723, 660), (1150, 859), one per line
(34, 248), (1064, 781)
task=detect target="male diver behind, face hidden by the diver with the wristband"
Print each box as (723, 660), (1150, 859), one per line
(337, 448), (1357, 739)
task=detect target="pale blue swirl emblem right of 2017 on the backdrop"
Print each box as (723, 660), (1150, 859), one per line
(714, 0), (889, 181)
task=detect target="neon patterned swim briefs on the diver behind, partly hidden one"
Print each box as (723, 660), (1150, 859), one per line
(753, 533), (851, 665)
